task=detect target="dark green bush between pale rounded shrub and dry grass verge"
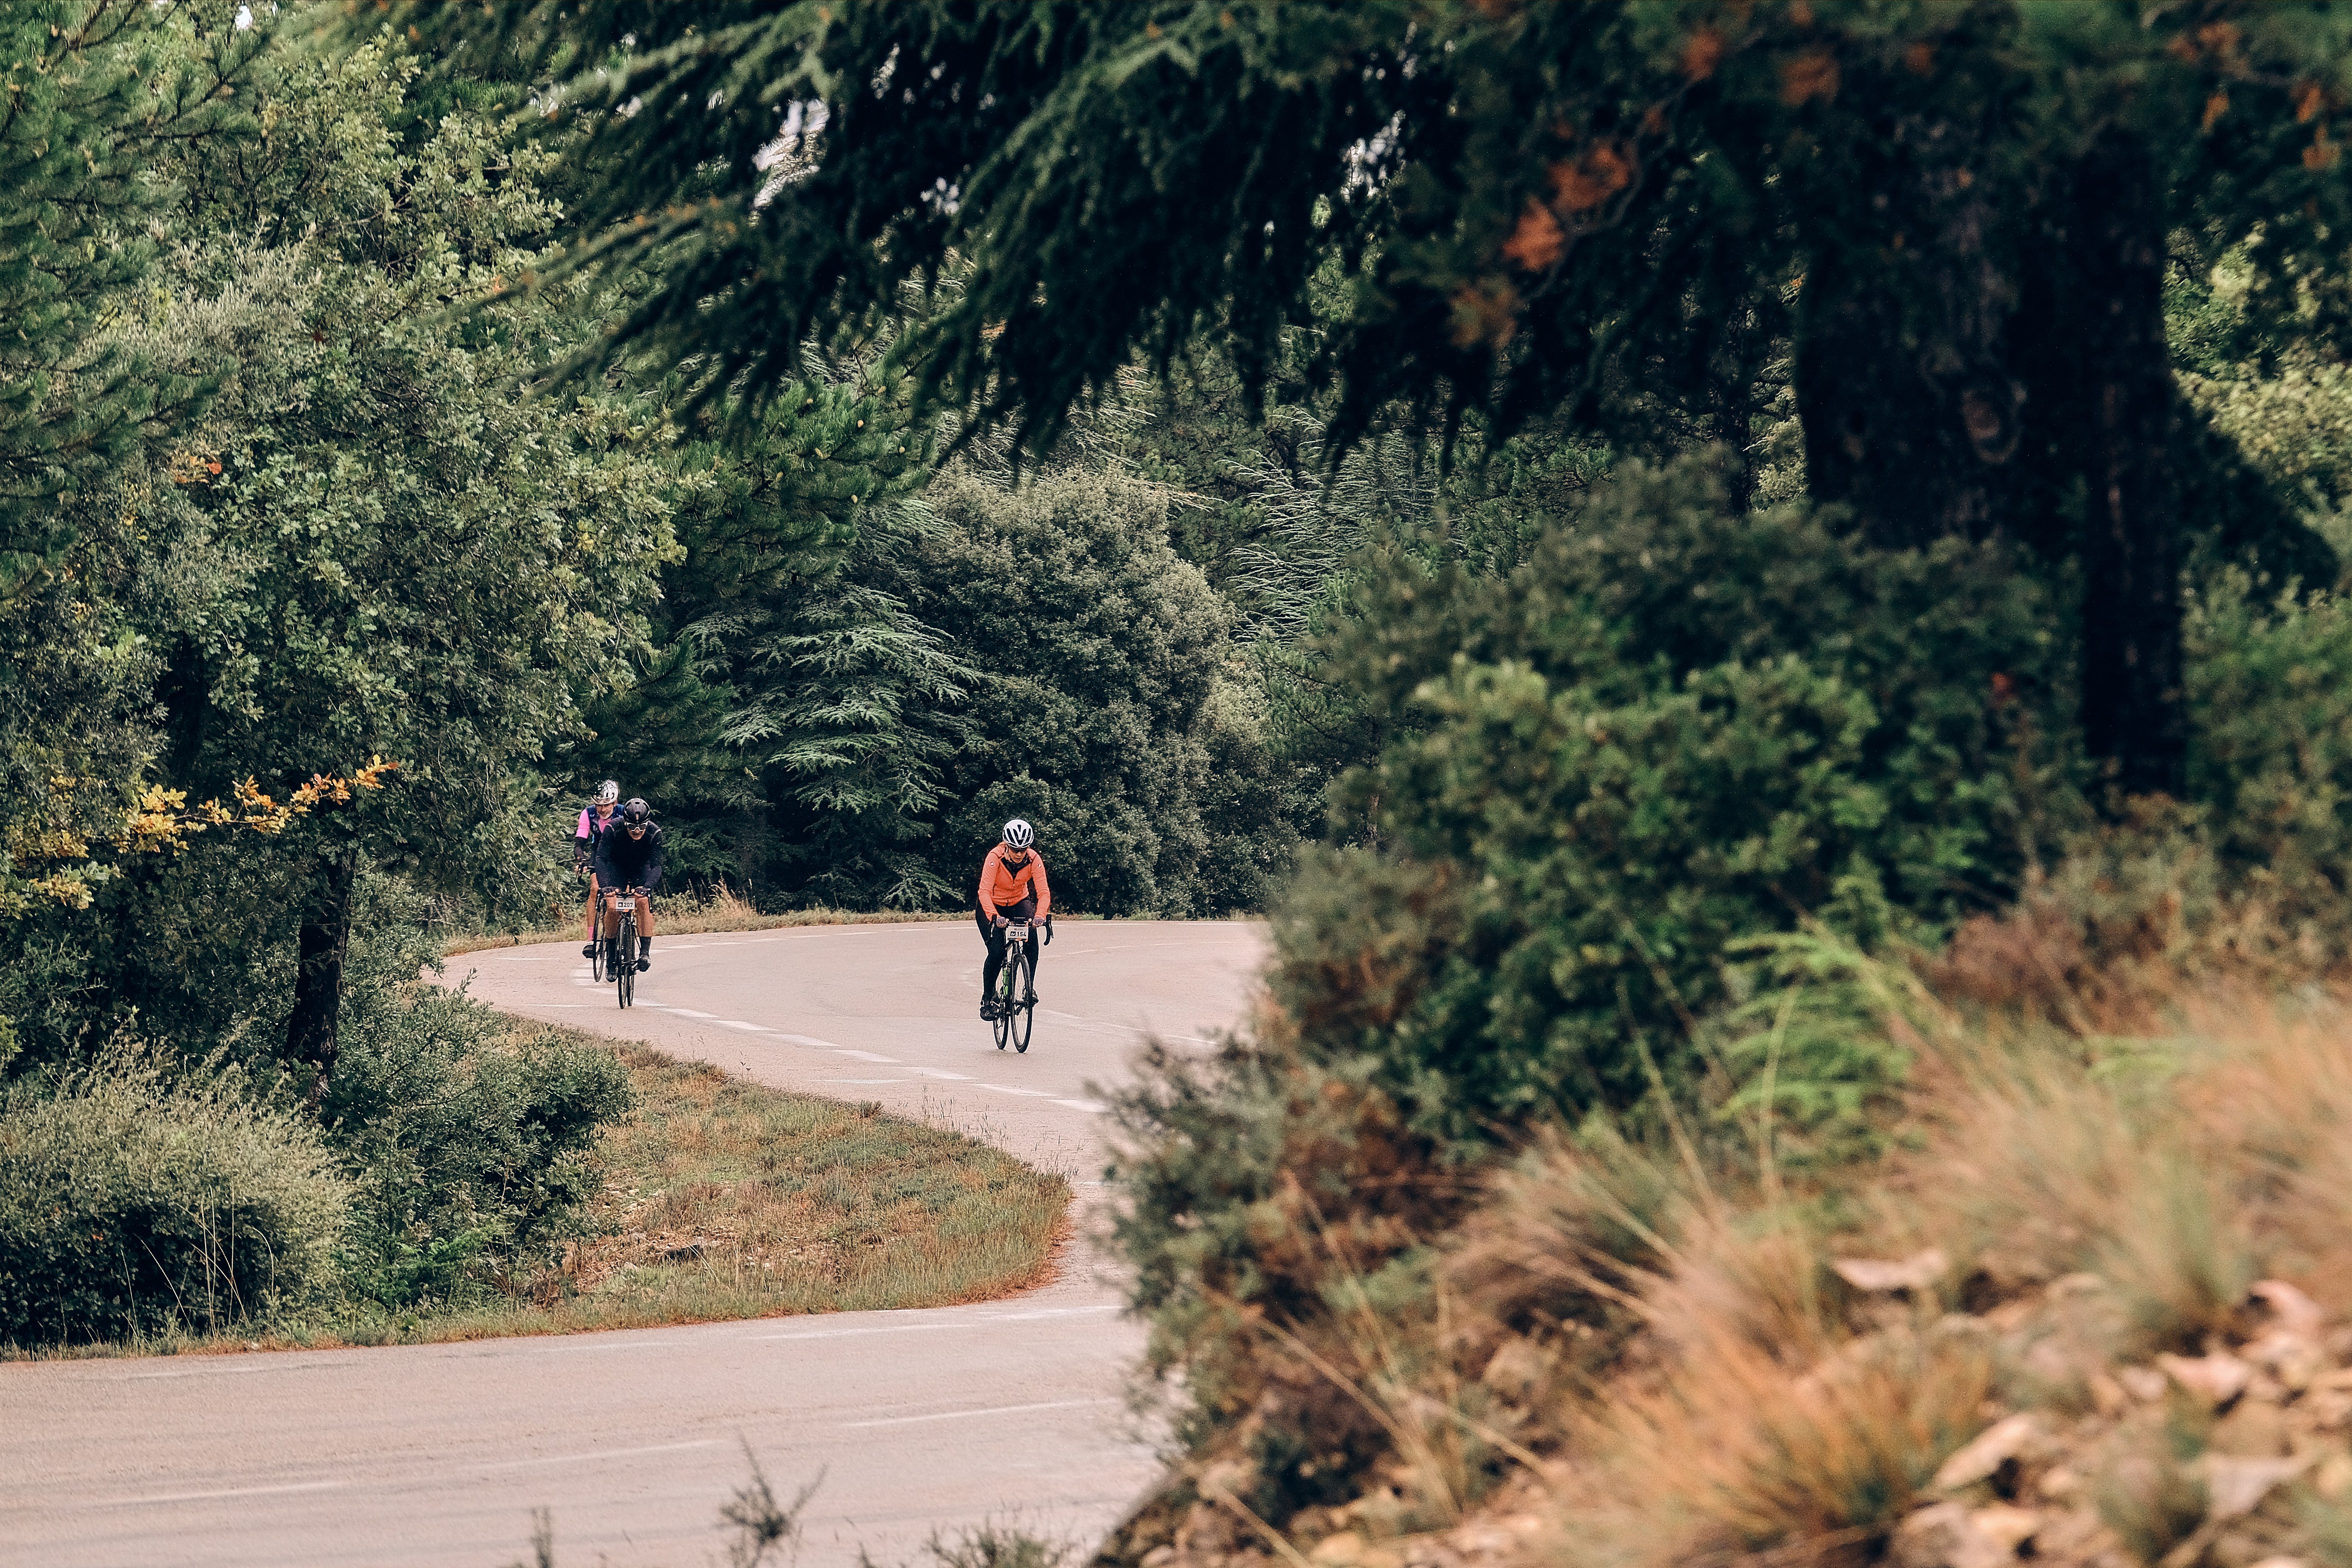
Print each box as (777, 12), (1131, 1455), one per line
(322, 980), (635, 1307)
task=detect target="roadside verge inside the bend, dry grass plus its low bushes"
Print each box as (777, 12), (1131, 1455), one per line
(0, 1006), (1070, 1357)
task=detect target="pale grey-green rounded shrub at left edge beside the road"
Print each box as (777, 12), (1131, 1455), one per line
(0, 1049), (351, 1344)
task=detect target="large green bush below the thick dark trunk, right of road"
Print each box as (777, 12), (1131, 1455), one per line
(1275, 463), (2075, 1145)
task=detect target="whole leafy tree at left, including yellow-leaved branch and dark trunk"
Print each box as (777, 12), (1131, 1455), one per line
(0, 38), (673, 1065)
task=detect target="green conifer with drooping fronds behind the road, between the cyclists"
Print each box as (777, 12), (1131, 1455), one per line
(579, 364), (967, 905)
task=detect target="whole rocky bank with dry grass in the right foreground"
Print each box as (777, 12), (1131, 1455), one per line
(1122, 846), (2352, 1568)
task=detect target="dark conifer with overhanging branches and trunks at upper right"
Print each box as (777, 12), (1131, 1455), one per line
(381, 0), (2352, 792)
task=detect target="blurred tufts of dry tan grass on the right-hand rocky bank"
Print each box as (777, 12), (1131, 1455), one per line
(1514, 987), (2352, 1568)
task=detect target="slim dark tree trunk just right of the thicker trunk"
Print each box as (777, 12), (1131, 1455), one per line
(2067, 134), (2187, 795)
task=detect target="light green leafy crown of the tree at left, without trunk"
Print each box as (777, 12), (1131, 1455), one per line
(149, 37), (670, 886)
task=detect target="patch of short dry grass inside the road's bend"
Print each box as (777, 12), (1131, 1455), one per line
(7, 1034), (1070, 1357)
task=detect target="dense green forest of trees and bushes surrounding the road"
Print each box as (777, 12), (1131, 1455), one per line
(0, 0), (2352, 1561)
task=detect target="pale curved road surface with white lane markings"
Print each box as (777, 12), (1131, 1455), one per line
(0, 922), (1263, 1568)
